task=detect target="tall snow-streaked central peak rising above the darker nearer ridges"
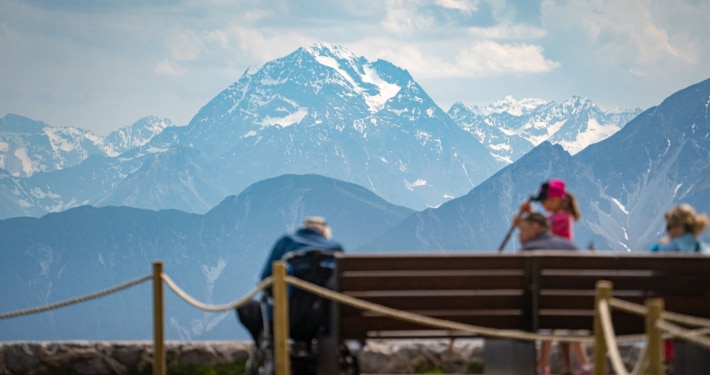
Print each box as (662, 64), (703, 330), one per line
(172, 43), (500, 212)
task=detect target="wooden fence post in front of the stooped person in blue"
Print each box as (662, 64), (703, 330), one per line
(271, 262), (291, 375)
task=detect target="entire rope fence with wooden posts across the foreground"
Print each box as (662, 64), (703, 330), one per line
(0, 262), (710, 375)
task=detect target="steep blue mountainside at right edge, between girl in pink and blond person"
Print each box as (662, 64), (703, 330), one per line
(576, 80), (710, 249)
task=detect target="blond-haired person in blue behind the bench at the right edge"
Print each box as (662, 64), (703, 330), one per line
(651, 204), (708, 253)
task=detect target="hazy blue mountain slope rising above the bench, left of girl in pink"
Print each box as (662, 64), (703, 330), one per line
(358, 142), (574, 251)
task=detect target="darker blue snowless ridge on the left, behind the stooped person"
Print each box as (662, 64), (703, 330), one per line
(0, 175), (413, 340)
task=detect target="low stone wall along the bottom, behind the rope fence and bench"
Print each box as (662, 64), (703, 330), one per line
(0, 340), (638, 375)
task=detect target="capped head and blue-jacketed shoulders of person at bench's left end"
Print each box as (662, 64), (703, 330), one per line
(261, 216), (343, 280)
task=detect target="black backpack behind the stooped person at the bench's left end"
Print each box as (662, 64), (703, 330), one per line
(283, 249), (335, 341)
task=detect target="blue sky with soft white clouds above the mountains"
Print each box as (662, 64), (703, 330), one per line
(0, 0), (710, 135)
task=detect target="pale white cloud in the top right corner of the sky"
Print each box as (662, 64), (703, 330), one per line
(542, 0), (710, 72)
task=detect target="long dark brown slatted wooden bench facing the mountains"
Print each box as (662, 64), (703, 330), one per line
(322, 251), (710, 373)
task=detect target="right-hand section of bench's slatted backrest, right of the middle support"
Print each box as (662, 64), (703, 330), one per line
(532, 252), (710, 334)
